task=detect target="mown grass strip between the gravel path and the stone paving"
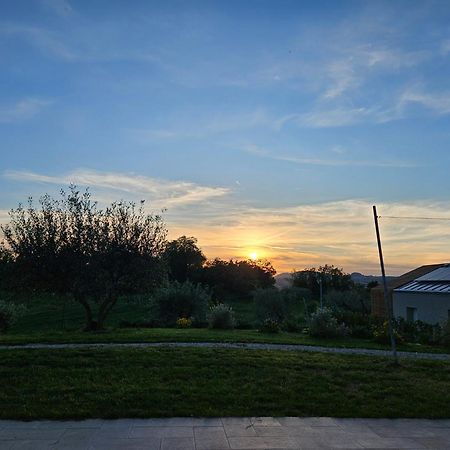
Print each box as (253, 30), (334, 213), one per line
(0, 348), (450, 420)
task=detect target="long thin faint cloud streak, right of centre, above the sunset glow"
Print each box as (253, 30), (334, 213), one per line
(242, 145), (416, 168)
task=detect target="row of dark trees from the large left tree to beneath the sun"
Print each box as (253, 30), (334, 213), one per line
(0, 186), (275, 330)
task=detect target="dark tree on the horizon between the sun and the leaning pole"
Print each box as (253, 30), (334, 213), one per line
(292, 264), (353, 298)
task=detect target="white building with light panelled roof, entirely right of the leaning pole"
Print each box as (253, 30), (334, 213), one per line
(392, 264), (450, 324)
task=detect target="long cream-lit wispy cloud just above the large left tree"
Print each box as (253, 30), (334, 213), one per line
(4, 169), (230, 208)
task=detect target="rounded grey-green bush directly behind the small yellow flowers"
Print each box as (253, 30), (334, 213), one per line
(151, 281), (211, 327)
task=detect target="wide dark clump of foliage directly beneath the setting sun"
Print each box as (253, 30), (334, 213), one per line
(198, 258), (276, 299)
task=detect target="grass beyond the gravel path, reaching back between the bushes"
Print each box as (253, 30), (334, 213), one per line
(0, 295), (450, 353)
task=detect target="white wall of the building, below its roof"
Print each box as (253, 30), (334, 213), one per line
(393, 291), (450, 324)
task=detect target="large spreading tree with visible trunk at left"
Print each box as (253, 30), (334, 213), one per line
(2, 186), (166, 330)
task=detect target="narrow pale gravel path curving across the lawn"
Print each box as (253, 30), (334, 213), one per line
(0, 342), (450, 361)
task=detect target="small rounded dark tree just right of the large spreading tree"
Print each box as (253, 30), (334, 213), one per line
(164, 236), (206, 283)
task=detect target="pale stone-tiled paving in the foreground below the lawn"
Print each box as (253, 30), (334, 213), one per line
(0, 417), (450, 450)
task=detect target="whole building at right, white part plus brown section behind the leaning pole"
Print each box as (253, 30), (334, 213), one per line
(371, 264), (450, 324)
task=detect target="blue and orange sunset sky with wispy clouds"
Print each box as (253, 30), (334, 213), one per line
(0, 0), (450, 274)
